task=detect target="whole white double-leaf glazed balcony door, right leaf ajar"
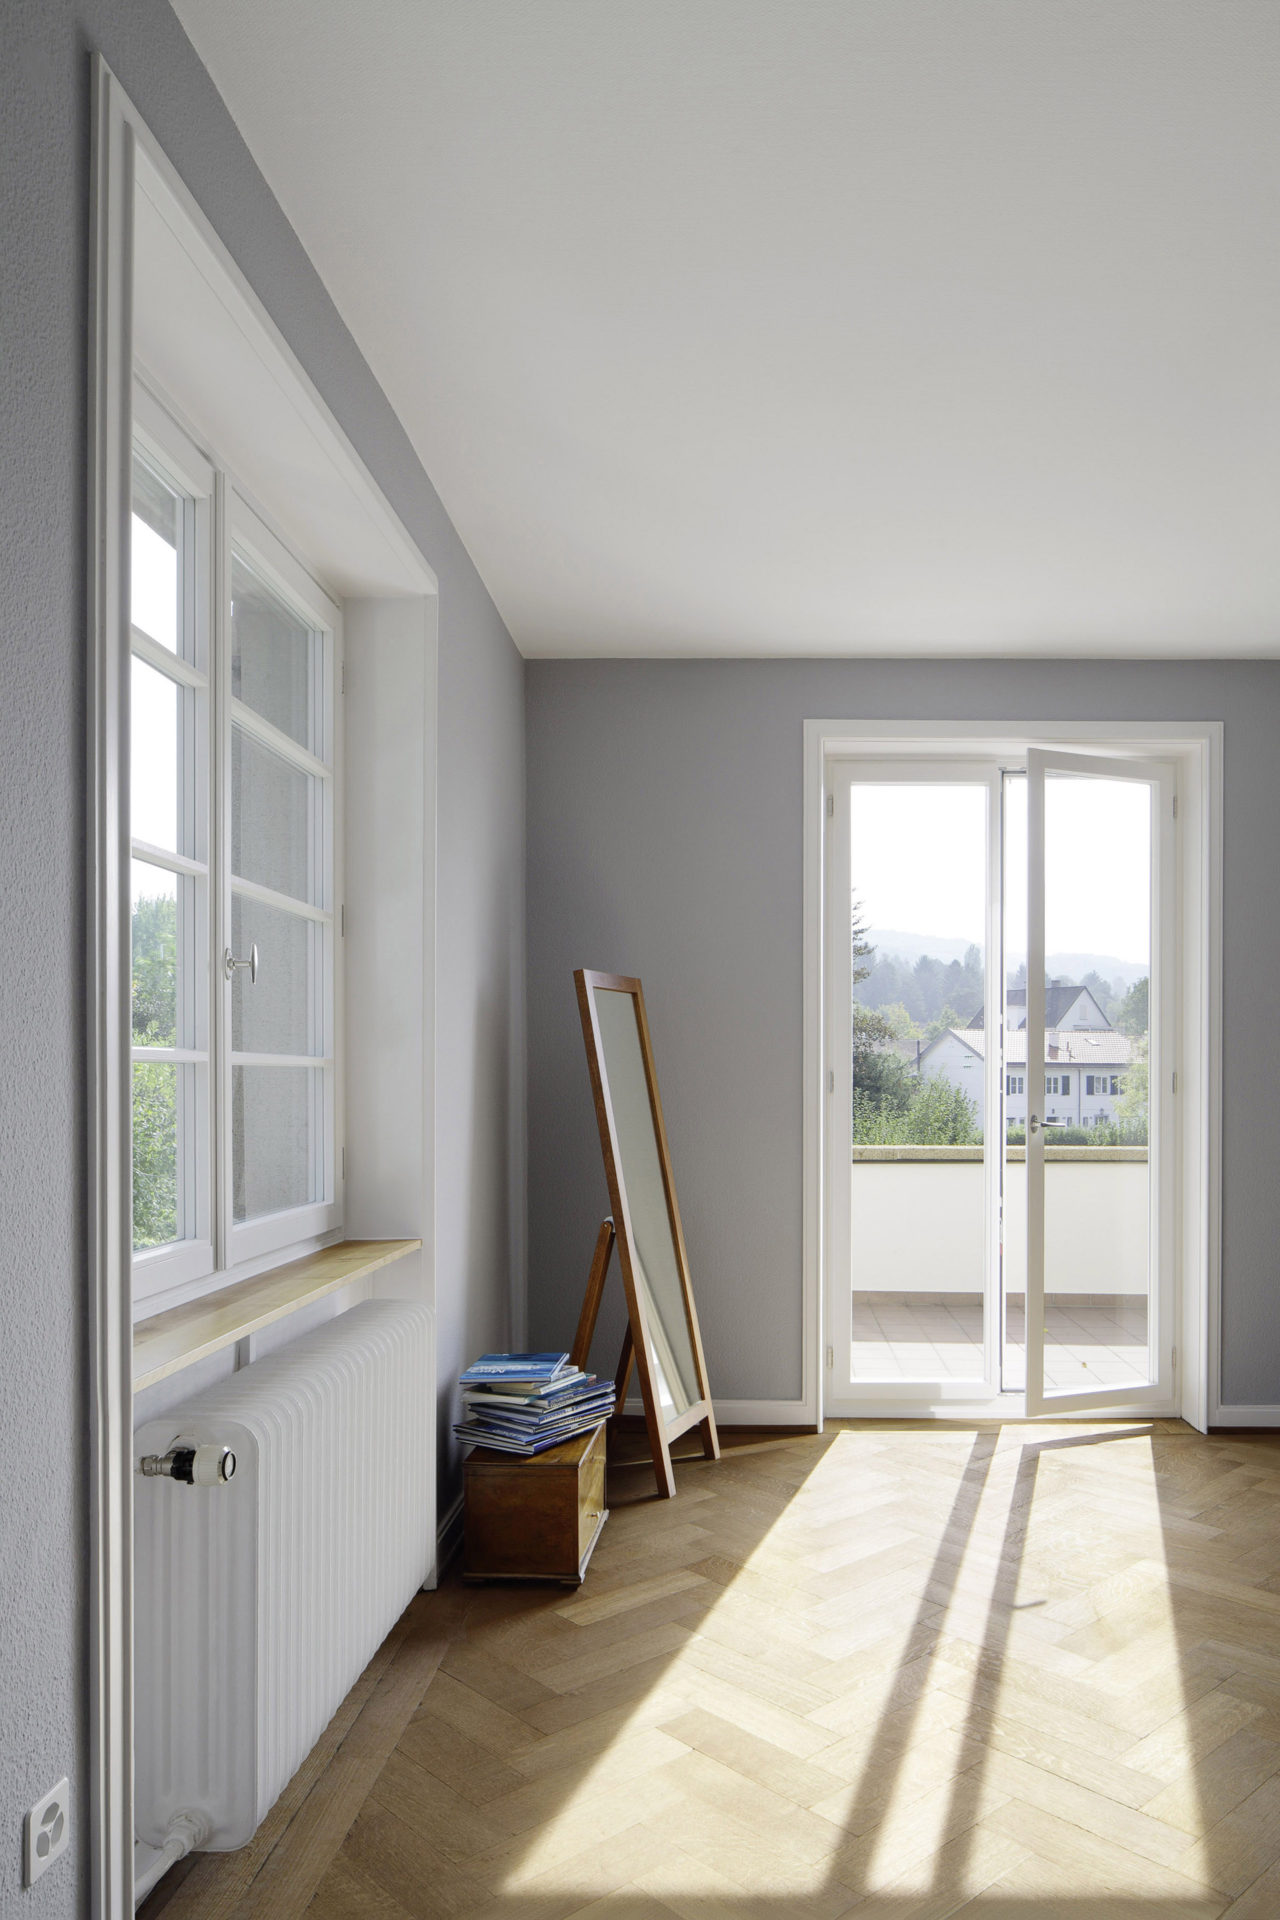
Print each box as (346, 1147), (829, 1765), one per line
(823, 747), (1174, 1417)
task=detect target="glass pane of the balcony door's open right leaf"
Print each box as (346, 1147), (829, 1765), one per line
(1028, 753), (1161, 1411)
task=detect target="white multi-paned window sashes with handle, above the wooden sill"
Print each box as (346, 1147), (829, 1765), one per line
(130, 395), (345, 1319)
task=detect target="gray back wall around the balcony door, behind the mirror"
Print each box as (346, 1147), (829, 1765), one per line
(526, 660), (1280, 1405)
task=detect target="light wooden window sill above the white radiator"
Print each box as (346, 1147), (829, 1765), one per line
(132, 1240), (422, 1394)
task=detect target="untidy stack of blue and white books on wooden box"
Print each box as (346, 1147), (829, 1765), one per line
(453, 1354), (614, 1453)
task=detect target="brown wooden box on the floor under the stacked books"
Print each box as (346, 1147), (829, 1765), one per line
(462, 1421), (608, 1586)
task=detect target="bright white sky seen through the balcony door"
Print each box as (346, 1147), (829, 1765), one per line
(850, 776), (1151, 966)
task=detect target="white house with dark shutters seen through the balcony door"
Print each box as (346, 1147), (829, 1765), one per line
(917, 1021), (1132, 1127)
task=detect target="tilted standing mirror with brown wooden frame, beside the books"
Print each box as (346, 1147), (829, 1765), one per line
(574, 968), (720, 1498)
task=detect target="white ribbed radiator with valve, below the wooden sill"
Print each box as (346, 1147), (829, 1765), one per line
(134, 1300), (436, 1849)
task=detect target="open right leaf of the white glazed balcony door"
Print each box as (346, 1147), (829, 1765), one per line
(1006, 749), (1174, 1413)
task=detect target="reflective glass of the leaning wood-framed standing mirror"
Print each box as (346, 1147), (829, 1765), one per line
(593, 987), (699, 1419)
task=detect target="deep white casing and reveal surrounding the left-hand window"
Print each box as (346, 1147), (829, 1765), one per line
(84, 54), (439, 1920)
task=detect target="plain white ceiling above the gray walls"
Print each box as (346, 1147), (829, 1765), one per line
(175, 0), (1280, 655)
